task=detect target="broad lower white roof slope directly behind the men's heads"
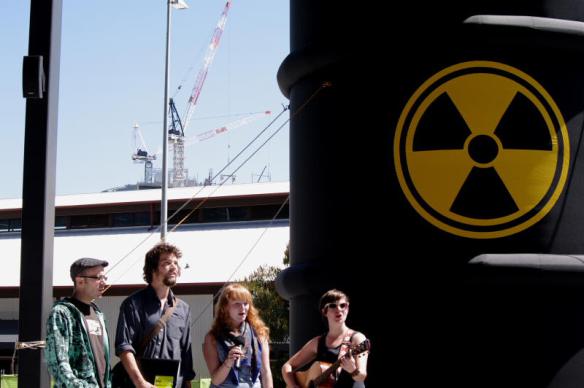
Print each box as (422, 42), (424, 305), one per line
(0, 220), (290, 287)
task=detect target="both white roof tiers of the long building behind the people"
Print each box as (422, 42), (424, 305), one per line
(0, 182), (289, 287)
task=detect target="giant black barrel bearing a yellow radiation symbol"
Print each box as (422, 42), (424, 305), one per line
(278, 0), (584, 387)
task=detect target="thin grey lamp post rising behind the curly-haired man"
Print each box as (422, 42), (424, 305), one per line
(160, 0), (189, 241)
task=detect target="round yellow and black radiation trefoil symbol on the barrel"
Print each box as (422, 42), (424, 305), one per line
(394, 61), (570, 238)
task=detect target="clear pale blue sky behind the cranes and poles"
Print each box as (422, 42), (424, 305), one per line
(0, 0), (289, 198)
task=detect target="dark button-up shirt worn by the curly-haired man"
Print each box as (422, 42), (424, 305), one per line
(116, 286), (195, 387)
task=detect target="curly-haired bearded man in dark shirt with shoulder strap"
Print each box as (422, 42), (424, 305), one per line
(115, 243), (195, 388)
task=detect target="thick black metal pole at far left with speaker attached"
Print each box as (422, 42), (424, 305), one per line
(18, 0), (62, 387)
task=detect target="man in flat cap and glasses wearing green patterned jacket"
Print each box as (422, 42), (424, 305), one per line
(45, 257), (111, 388)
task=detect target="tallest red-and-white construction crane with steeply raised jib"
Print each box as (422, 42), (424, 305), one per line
(168, 0), (231, 187)
